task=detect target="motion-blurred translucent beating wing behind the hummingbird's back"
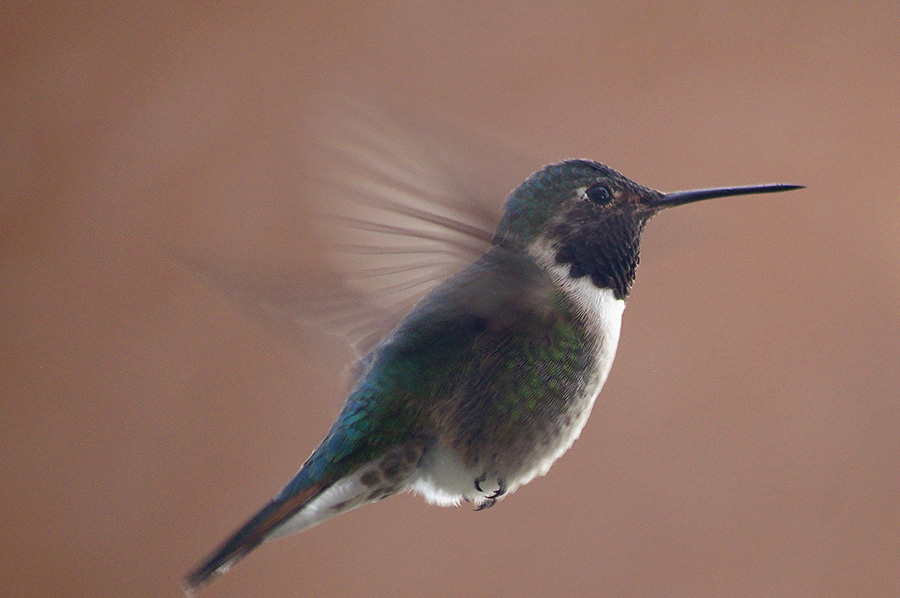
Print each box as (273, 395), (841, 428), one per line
(187, 94), (533, 366)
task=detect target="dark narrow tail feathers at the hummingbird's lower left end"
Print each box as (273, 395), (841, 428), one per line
(183, 483), (328, 595)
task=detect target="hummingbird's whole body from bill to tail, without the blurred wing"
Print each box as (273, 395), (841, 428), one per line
(184, 160), (802, 593)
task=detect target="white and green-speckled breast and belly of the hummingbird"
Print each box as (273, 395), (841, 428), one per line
(410, 258), (625, 504)
